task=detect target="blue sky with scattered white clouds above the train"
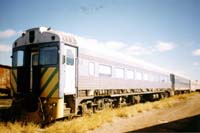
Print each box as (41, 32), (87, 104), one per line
(0, 0), (200, 80)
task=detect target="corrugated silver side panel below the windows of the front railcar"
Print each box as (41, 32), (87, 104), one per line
(79, 76), (171, 90)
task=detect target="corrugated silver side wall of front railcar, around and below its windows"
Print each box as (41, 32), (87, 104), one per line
(78, 54), (171, 90)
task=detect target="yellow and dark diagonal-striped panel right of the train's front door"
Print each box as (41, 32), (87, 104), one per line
(40, 67), (59, 98)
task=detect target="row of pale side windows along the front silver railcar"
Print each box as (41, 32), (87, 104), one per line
(88, 62), (169, 83)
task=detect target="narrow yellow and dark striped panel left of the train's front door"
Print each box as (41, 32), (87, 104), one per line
(11, 69), (17, 93)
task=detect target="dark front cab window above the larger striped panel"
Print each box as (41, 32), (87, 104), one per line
(40, 47), (58, 65)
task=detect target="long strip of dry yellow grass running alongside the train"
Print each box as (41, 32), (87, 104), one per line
(0, 93), (199, 133)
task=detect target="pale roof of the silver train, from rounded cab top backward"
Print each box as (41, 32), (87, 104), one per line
(13, 27), (191, 78)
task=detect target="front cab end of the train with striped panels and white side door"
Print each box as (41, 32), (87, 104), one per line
(11, 27), (78, 121)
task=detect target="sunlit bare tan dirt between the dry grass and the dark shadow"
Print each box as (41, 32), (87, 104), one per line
(90, 94), (200, 133)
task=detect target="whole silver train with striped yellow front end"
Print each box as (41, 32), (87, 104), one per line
(8, 27), (192, 121)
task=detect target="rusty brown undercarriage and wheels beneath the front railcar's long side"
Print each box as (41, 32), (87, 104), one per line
(77, 89), (173, 115)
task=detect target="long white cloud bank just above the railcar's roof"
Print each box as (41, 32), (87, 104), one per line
(76, 36), (175, 56)
